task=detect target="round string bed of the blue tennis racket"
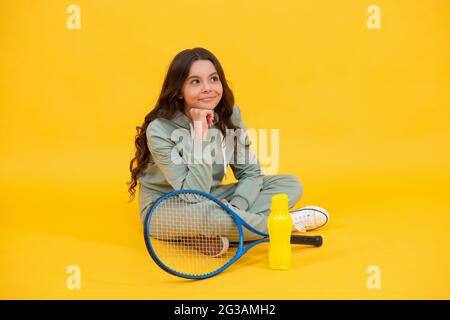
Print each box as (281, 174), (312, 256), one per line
(150, 193), (239, 276)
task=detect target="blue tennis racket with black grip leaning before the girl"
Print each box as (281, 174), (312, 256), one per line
(144, 190), (322, 279)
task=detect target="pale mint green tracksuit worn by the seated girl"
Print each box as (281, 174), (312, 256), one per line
(139, 106), (303, 240)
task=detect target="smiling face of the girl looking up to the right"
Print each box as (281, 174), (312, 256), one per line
(182, 60), (223, 114)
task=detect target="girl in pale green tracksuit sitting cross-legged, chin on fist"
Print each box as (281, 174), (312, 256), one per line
(128, 48), (329, 255)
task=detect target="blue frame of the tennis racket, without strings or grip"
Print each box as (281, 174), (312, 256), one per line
(144, 189), (269, 280)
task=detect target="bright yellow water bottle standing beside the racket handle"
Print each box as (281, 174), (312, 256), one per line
(267, 193), (292, 270)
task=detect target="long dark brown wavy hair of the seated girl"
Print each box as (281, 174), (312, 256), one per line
(127, 48), (243, 202)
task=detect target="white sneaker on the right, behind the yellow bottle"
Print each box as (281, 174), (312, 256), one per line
(290, 206), (330, 232)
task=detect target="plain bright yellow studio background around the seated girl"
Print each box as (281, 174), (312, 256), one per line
(0, 0), (450, 299)
